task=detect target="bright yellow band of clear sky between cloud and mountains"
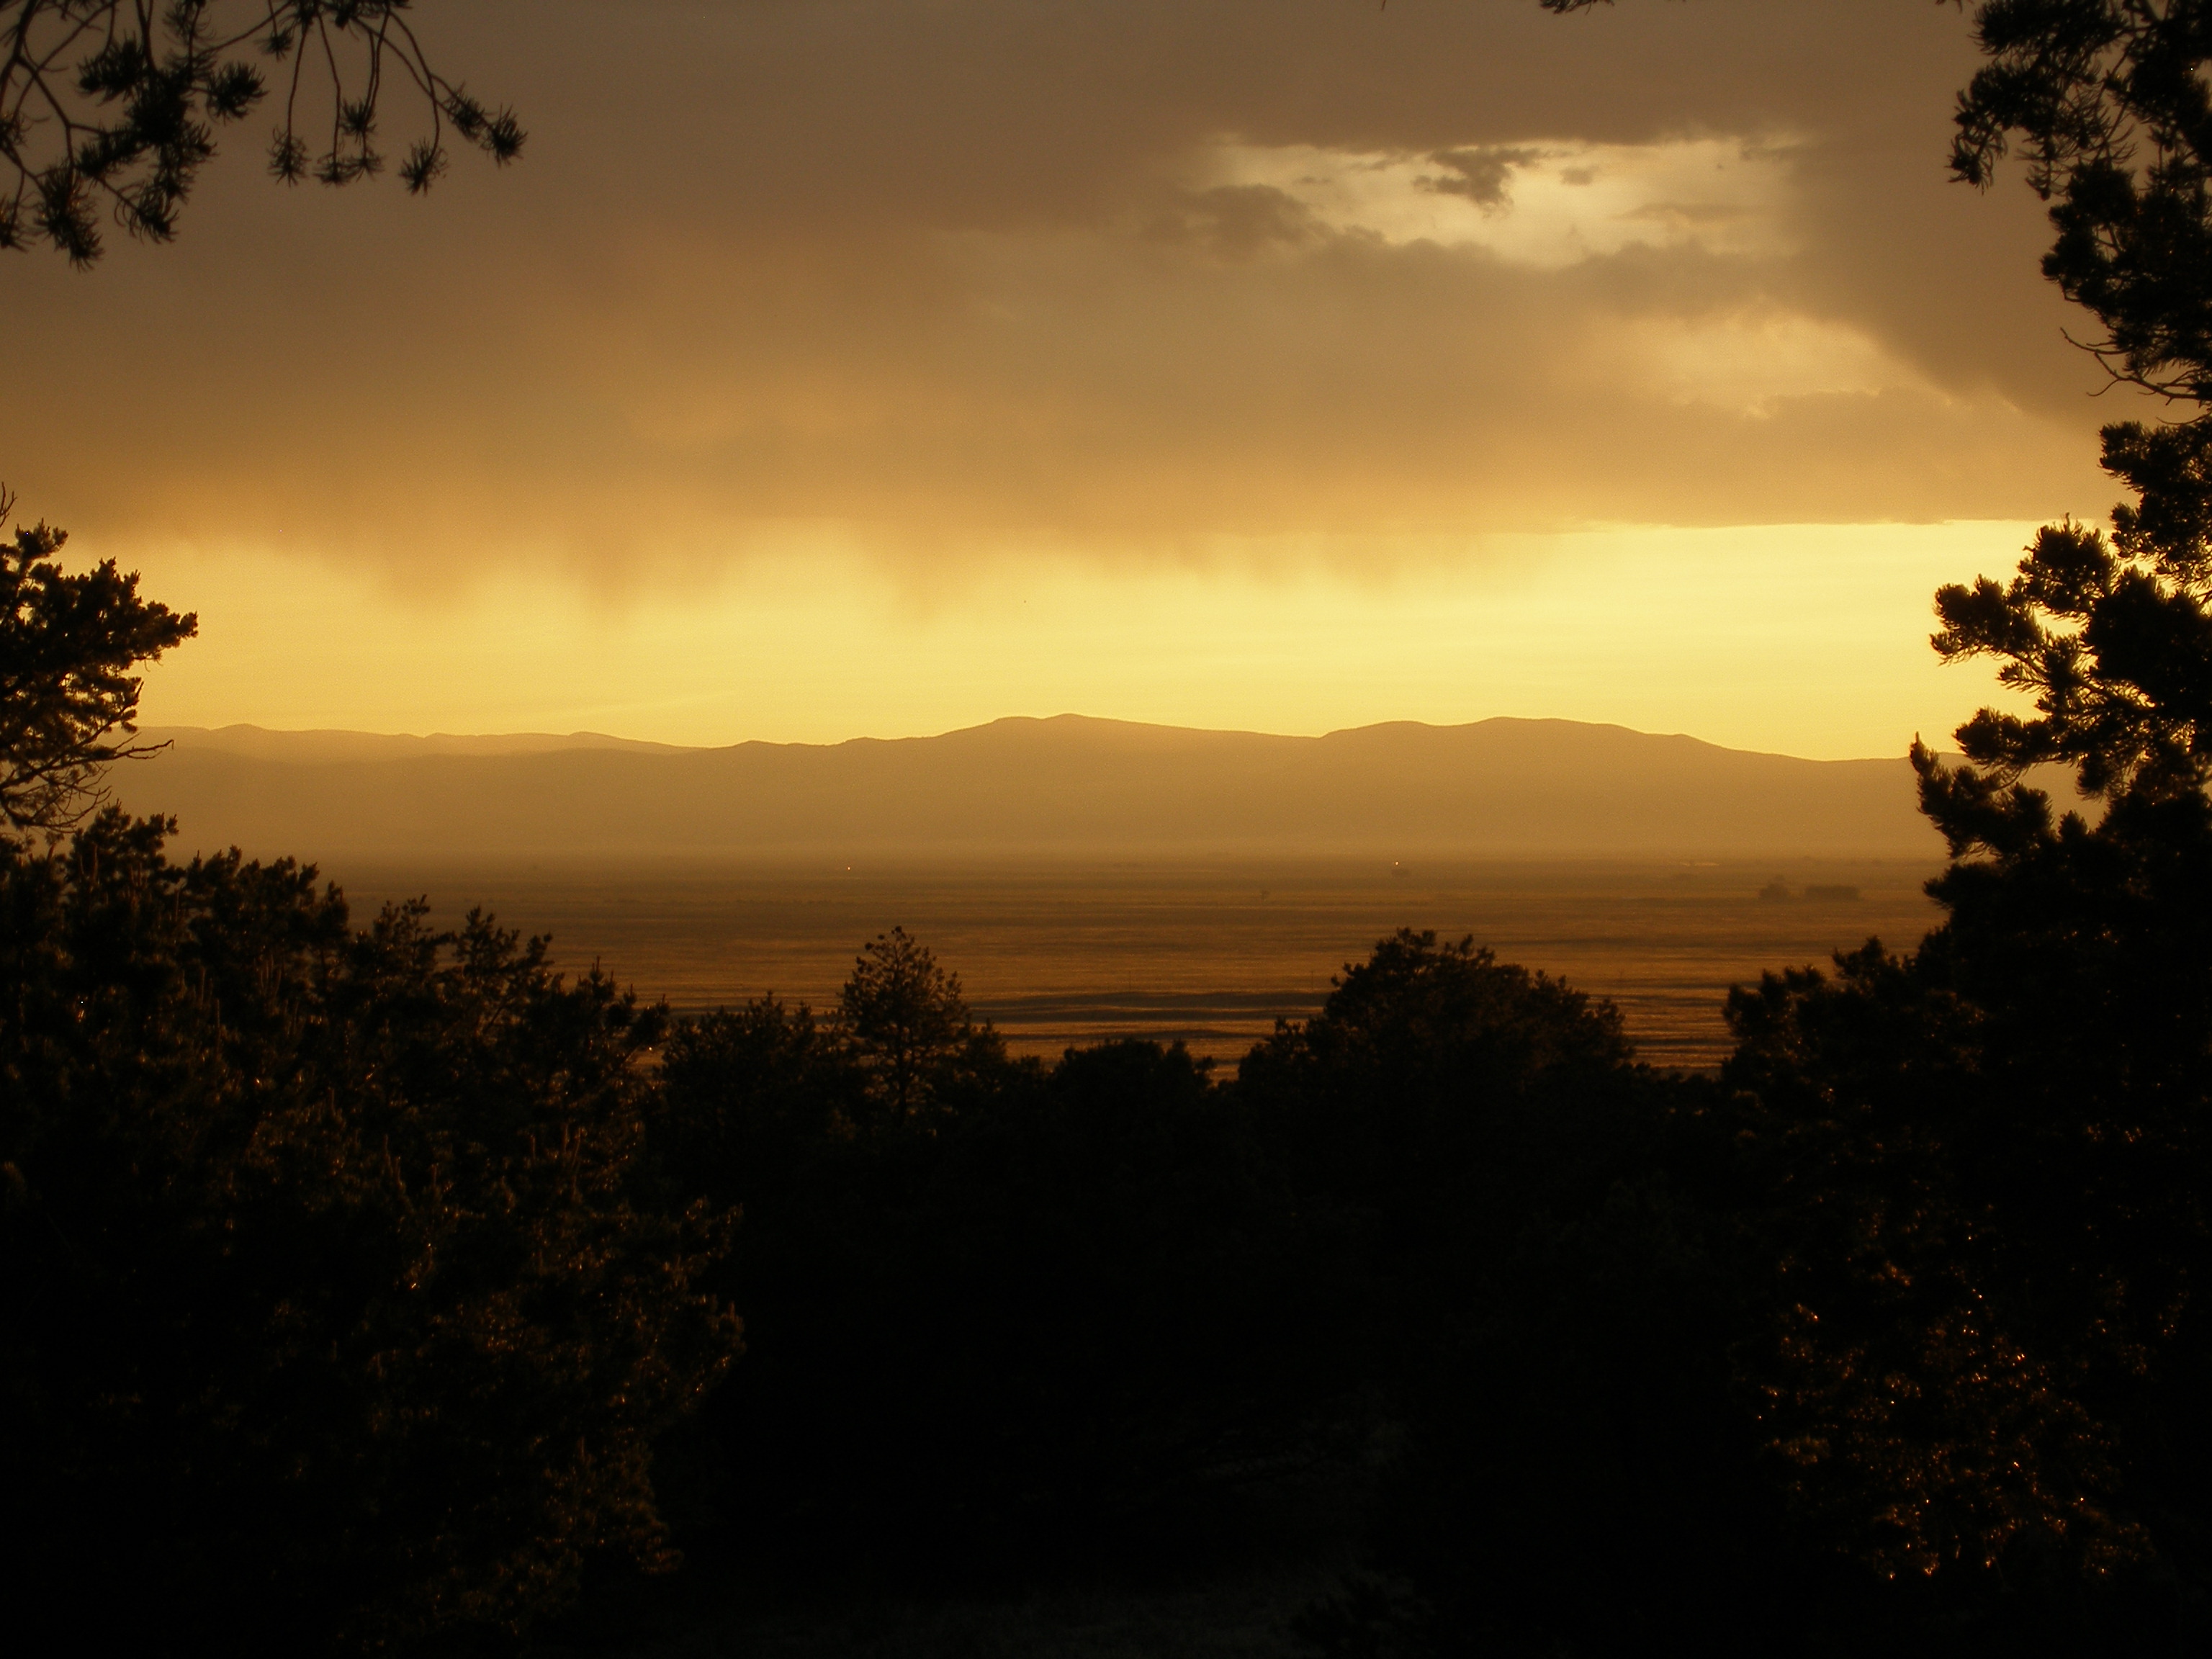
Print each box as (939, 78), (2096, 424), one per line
(132, 522), (2033, 759)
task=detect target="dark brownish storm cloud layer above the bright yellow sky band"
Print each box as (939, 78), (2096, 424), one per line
(0, 0), (2110, 569)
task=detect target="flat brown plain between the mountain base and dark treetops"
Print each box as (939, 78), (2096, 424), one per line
(328, 858), (1936, 1066)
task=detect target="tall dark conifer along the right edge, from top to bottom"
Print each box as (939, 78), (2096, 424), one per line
(1730, 19), (2212, 1641)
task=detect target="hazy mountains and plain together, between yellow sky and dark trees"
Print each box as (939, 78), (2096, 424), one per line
(129, 716), (1942, 1066)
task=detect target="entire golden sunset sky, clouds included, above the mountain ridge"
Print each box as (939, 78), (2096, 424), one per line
(0, 0), (2128, 757)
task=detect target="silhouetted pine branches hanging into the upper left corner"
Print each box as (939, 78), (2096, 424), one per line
(0, 0), (524, 266)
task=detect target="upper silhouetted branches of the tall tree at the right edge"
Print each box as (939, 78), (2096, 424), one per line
(1915, 0), (2212, 832)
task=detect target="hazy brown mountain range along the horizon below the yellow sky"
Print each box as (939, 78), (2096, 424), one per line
(111, 714), (1942, 858)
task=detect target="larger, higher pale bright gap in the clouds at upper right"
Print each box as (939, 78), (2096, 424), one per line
(1199, 137), (1789, 270)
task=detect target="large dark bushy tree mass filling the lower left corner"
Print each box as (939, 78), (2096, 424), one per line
(0, 814), (737, 1650)
